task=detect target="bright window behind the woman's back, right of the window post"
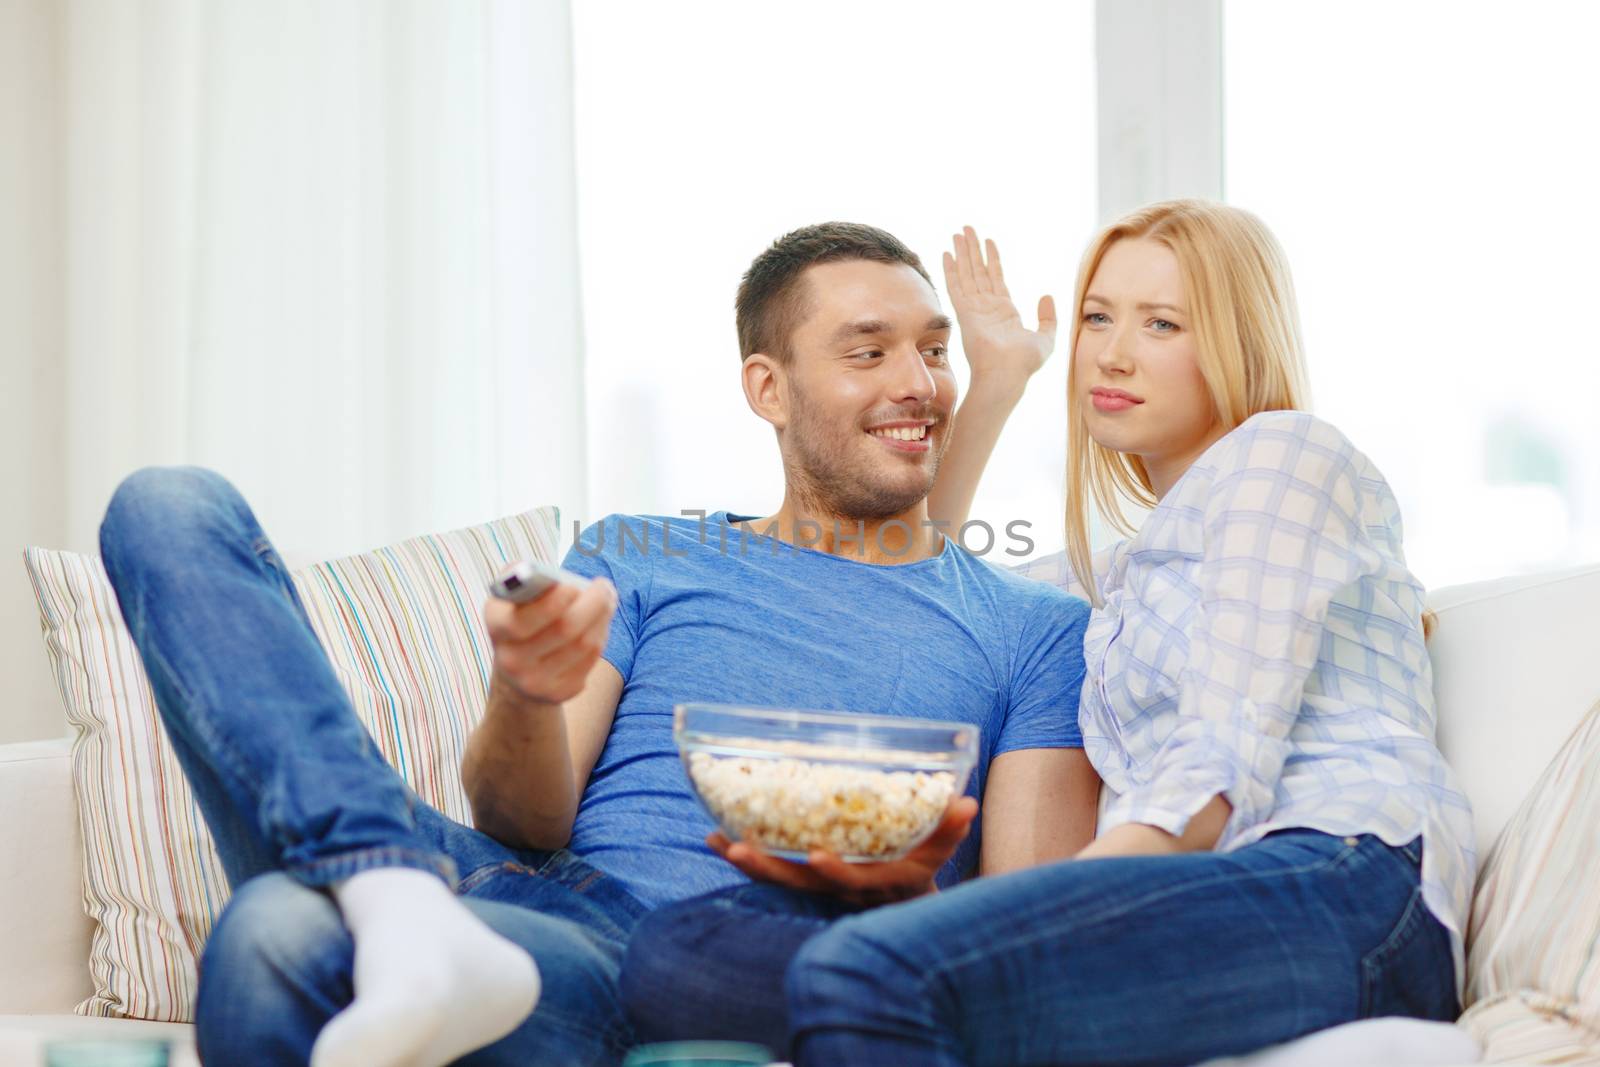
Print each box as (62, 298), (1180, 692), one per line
(1224, 0), (1600, 587)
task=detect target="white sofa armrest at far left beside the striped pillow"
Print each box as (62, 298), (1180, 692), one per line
(0, 741), (91, 1014)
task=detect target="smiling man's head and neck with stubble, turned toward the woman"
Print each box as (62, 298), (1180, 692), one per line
(736, 235), (955, 557)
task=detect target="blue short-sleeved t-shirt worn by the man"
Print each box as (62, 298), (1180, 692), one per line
(563, 512), (1090, 905)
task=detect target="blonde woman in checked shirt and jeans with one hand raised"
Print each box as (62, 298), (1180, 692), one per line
(768, 200), (1474, 1067)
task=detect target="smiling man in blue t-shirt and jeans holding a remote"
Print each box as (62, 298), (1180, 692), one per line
(101, 224), (1096, 1067)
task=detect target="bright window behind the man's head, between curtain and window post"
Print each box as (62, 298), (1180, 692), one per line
(571, 0), (1094, 558)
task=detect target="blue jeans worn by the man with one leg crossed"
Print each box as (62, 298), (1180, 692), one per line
(101, 467), (645, 1067)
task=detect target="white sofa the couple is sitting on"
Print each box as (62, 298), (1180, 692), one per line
(0, 566), (1600, 1067)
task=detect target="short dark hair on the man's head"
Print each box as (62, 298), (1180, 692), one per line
(733, 222), (933, 360)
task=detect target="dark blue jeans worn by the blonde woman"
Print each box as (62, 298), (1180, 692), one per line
(622, 830), (1458, 1067)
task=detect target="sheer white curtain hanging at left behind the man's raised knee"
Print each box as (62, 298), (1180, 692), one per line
(0, 0), (586, 741)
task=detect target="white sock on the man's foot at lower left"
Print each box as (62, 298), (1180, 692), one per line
(310, 867), (539, 1067)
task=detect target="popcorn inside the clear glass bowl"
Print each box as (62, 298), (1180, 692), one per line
(686, 739), (955, 861)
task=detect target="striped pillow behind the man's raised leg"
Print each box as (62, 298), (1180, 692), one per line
(24, 509), (557, 1022)
